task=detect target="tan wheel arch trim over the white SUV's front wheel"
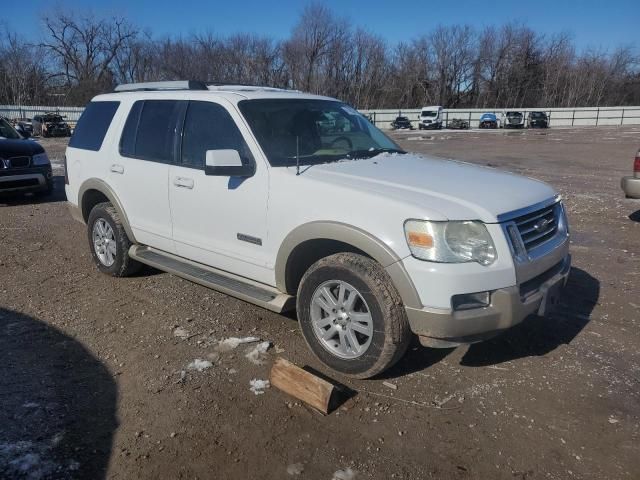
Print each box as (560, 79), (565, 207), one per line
(275, 221), (422, 308)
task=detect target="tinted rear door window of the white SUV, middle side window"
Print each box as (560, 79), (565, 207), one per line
(120, 100), (183, 163)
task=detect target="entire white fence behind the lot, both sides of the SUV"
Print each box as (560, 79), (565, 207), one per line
(0, 105), (640, 128)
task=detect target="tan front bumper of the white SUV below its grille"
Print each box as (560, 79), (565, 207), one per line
(405, 255), (571, 348)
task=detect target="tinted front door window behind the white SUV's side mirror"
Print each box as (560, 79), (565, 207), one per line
(182, 102), (252, 168)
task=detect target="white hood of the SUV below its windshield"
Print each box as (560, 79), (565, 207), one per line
(303, 153), (556, 223)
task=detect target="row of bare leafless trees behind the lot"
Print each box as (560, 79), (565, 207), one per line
(0, 4), (640, 109)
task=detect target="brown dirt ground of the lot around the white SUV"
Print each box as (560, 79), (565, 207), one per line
(0, 127), (640, 480)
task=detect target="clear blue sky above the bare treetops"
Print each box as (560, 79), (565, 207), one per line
(5, 0), (640, 49)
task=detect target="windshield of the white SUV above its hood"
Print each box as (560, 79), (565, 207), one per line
(238, 99), (404, 167)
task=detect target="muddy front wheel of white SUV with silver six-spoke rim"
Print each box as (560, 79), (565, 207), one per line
(296, 253), (412, 378)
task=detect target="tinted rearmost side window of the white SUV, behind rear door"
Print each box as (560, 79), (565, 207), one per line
(70, 102), (120, 152)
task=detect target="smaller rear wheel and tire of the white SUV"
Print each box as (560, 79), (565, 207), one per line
(87, 202), (142, 277)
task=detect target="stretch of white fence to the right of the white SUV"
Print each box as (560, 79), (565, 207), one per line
(360, 107), (640, 128)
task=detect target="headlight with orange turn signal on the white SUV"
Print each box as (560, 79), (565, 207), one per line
(404, 220), (498, 265)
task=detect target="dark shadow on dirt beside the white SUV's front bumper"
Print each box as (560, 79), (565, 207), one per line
(460, 267), (600, 367)
